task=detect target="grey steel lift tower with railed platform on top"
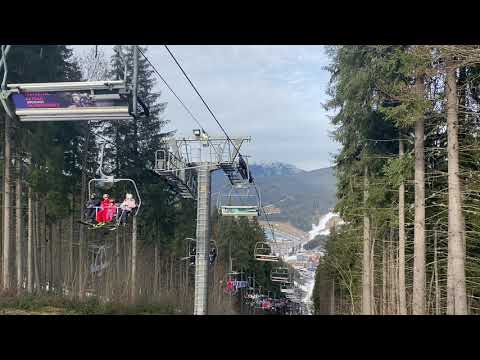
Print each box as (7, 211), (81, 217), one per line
(154, 129), (250, 315)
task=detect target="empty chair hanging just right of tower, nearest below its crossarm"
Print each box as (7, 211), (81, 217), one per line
(217, 184), (261, 217)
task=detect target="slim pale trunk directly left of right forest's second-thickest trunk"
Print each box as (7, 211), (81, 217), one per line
(398, 135), (407, 315)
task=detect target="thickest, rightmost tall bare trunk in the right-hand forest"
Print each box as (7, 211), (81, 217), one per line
(446, 64), (468, 315)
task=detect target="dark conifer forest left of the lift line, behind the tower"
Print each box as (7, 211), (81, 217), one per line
(0, 45), (286, 314)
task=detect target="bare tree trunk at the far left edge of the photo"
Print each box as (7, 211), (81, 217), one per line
(2, 114), (12, 289)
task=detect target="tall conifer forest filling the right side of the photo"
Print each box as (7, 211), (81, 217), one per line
(313, 45), (480, 315)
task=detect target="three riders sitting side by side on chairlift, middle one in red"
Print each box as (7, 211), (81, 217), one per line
(85, 193), (137, 226)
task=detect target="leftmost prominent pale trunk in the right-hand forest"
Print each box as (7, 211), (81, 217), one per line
(362, 165), (372, 315)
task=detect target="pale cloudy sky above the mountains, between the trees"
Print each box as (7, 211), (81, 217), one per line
(73, 45), (339, 170)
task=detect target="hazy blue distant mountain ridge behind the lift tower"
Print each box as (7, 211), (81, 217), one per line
(212, 162), (336, 231)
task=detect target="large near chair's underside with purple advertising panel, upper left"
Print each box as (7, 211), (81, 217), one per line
(4, 80), (133, 122)
